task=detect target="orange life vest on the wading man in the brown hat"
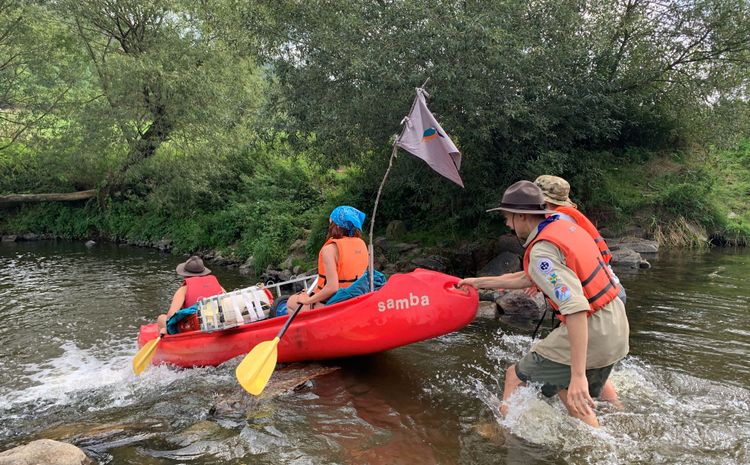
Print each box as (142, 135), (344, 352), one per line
(523, 220), (620, 323)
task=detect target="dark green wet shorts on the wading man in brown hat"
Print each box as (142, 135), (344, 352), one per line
(516, 352), (614, 397)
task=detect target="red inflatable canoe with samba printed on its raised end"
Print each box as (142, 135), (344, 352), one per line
(138, 268), (479, 368)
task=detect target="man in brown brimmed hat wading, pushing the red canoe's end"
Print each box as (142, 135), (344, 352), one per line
(459, 181), (629, 426)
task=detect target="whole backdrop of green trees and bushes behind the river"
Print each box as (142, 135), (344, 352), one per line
(0, 0), (750, 258)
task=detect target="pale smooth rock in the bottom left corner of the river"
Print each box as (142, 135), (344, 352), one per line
(0, 439), (93, 465)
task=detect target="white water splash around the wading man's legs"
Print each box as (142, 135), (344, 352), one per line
(426, 332), (750, 465)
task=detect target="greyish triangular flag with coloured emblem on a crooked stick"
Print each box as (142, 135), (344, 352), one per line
(396, 88), (464, 187)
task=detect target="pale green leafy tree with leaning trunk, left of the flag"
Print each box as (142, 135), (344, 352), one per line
(59, 0), (262, 190)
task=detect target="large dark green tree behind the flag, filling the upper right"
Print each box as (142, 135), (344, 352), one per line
(242, 0), (750, 221)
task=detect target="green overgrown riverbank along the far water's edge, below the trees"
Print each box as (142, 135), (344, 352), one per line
(0, 140), (750, 275)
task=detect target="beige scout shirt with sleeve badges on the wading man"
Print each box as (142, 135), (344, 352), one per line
(524, 219), (630, 369)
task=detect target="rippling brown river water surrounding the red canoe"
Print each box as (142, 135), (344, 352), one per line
(0, 242), (750, 464)
